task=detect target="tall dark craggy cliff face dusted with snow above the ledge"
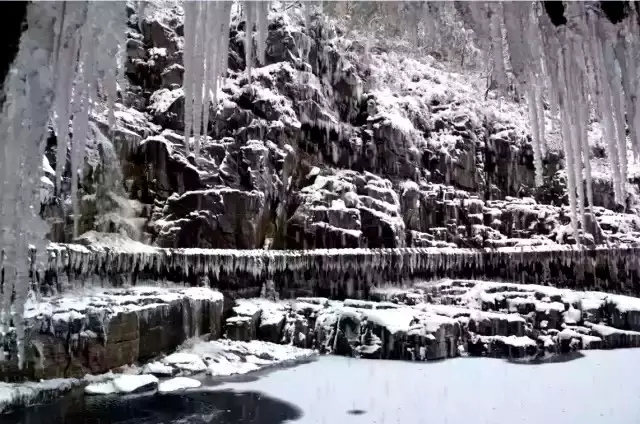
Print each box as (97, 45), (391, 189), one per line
(42, 2), (640, 249)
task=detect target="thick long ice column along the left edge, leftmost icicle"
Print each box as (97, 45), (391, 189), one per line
(0, 2), (62, 368)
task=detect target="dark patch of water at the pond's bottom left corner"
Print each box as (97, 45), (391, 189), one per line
(0, 390), (302, 424)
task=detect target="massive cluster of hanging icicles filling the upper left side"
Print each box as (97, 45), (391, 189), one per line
(0, 2), (126, 370)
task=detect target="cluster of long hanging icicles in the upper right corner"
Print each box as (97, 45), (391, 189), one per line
(469, 2), (640, 227)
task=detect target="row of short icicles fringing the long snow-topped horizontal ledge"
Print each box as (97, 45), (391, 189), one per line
(41, 238), (640, 292)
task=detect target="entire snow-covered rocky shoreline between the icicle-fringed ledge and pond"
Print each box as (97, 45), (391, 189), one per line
(0, 280), (640, 408)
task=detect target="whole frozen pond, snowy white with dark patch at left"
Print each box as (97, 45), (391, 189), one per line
(6, 349), (640, 424)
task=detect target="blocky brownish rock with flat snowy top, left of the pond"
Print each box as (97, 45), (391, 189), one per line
(0, 287), (223, 381)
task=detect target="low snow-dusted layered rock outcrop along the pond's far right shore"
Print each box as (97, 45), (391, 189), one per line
(219, 280), (640, 361)
